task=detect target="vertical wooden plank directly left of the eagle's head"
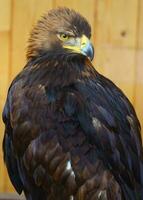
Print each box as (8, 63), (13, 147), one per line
(11, 0), (52, 79)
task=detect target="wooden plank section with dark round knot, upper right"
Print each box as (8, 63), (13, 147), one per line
(96, 0), (138, 48)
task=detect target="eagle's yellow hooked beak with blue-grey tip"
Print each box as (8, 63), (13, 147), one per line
(63, 35), (94, 61)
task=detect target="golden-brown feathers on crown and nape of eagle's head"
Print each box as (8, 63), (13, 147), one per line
(27, 8), (91, 59)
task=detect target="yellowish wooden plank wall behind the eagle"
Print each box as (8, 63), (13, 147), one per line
(0, 0), (143, 192)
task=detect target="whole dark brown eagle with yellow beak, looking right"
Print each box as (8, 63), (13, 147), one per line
(3, 8), (143, 200)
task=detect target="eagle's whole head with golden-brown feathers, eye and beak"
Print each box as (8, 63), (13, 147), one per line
(27, 8), (94, 60)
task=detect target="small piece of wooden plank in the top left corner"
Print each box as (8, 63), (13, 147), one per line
(0, 0), (11, 31)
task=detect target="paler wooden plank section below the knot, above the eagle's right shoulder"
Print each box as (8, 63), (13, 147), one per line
(96, 45), (135, 102)
